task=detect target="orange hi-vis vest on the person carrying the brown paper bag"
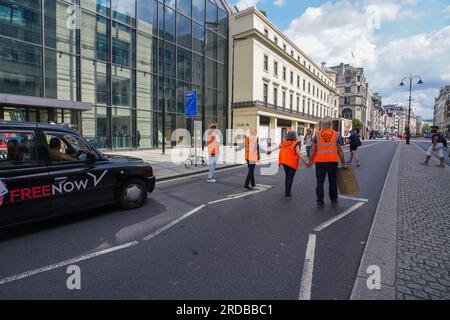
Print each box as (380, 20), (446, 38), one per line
(313, 128), (340, 163)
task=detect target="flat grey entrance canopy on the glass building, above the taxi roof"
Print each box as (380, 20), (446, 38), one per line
(0, 93), (93, 111)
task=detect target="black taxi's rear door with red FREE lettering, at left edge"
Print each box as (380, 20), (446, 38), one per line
(0, 125), (52, 227)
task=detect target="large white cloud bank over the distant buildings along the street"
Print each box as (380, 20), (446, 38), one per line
(285, 0), (450, 117)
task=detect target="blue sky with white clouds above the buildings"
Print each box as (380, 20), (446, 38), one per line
(229, 0), (450, 119)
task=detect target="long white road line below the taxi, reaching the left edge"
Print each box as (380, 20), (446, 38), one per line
(0, 241), (139, 285)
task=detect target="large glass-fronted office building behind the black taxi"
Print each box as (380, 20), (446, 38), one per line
(0, 0), (230, 149)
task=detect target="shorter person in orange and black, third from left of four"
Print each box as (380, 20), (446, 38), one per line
(269, 130), (306, 199)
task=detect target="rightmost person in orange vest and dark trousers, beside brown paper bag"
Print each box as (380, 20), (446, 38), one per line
(308, 117), (348, 208)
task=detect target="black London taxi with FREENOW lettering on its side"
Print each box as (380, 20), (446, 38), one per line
(0, 120), (155, 228)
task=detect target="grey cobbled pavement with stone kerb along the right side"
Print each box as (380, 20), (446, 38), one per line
(351, 140), (450, 300)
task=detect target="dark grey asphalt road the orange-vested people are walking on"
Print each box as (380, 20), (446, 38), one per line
(0, 141), (397, 300)
